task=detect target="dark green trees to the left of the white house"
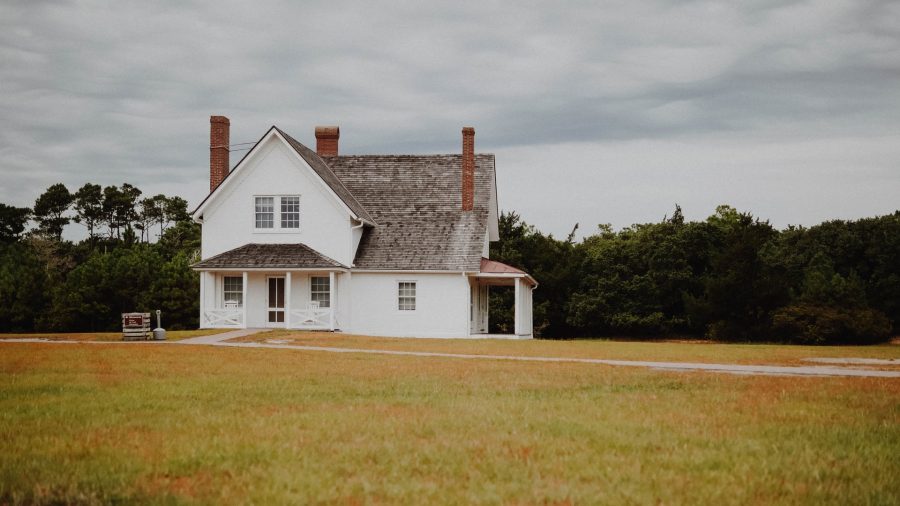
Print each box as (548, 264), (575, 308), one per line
(0, 183), (200, 332)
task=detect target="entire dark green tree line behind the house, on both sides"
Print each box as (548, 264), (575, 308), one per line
(0, 183), (900, 344)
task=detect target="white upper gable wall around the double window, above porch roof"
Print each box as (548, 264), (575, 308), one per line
(202, 136), (353, 265)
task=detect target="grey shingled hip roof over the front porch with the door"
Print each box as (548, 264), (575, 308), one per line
(191, 243), (348, 270)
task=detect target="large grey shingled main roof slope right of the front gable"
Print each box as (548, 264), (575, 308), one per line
(322, 154), (494, 272)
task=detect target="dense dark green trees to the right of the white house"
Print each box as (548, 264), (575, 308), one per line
(491, 206), (900, 344)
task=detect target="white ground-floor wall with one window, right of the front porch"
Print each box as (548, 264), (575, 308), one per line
(343, 272), (469, 337)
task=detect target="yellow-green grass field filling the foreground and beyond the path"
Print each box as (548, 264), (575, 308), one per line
(0, 334), (900, 504)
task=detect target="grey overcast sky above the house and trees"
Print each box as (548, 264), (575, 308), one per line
(0, 0), (900, 236)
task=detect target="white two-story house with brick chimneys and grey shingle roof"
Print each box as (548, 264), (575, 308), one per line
(193, 116), (537, 338)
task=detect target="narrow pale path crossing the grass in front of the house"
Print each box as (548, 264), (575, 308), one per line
(0, 329), (900, 378)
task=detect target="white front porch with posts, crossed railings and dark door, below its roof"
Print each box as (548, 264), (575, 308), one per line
(200, 270), (341, 330)
